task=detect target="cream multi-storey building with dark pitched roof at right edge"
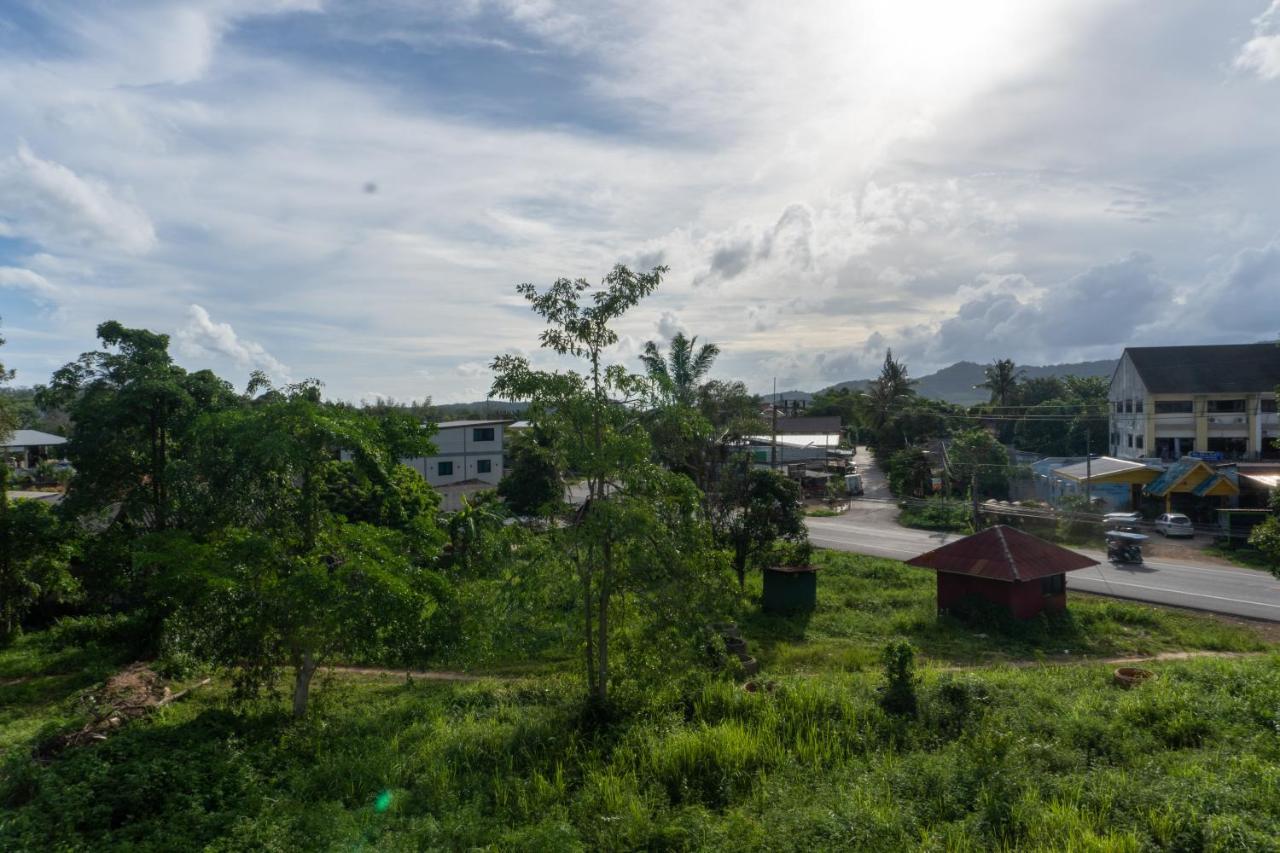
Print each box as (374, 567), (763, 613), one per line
(1107, 343), (1280, 461)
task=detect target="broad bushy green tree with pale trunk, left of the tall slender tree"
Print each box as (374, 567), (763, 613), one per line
(147, 375), (444, 716)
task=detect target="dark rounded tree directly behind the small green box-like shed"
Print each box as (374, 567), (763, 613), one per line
(714, 455), (808, 588)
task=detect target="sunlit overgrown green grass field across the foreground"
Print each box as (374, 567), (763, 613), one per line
(0, 552), (1280, 850)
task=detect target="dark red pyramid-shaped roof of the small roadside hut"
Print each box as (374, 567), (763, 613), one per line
(906, 524), (1098, 583)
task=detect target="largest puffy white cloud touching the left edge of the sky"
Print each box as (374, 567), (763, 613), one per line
(0, 143), (156, 255)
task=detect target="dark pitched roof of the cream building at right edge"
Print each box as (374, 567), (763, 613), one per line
(1125, 343), (1280, 394)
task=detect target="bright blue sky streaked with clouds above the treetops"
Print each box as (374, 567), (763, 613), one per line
(0, 0), (1280, 402)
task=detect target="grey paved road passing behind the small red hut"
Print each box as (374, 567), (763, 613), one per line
(808, 448), (1280, 621)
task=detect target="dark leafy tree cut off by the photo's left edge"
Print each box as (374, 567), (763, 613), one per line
(0, 465), (77, 643)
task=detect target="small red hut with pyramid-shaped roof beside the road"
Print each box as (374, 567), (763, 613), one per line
(906, 524), (1098, 619)
